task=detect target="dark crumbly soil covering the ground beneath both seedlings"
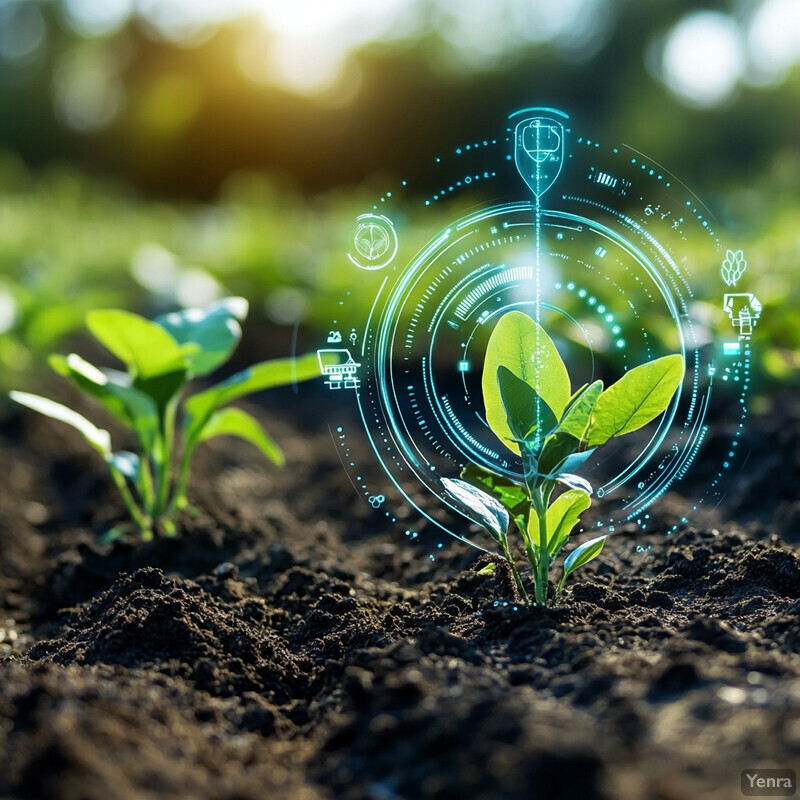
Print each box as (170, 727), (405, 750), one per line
(0, 382), (800, 800)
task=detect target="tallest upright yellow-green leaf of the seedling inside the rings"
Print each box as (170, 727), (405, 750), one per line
(482, 311), (570, 453)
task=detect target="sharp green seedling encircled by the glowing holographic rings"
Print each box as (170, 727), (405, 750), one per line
(443, 311), (684, 606)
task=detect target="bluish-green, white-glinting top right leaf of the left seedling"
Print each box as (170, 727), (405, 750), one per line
(155, 297), (248, 375)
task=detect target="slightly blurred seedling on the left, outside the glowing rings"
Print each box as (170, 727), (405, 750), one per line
(10, 297), (319, 540)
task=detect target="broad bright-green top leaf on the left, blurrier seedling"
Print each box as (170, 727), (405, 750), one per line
(86, 309), (197, 379)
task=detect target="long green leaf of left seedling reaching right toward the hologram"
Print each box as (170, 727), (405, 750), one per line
(185, 353), (320, 442)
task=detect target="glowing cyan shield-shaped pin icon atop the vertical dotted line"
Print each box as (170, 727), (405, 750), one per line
(514, 115), (564, 200)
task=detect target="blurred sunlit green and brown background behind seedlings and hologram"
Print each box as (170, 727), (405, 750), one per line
(0, 0), (800, 396)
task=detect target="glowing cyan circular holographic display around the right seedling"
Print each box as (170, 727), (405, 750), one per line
(318, 108), (762, 547)
